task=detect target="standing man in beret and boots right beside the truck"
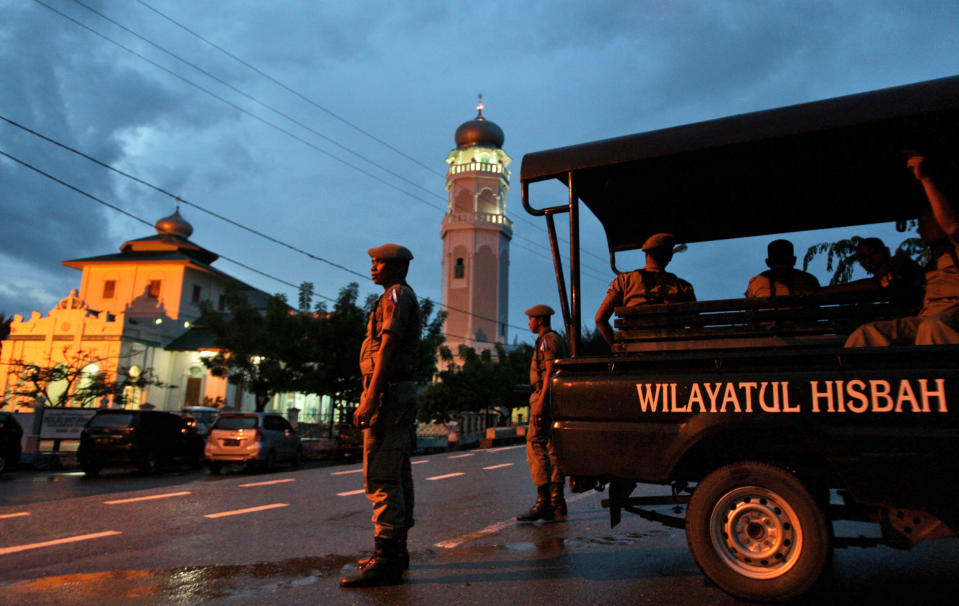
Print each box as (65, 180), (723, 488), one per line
(516, 305), (566, 522)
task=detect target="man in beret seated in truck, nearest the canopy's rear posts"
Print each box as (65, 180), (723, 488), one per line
(596, 233), (696, 346)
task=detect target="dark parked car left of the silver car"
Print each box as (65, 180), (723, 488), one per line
(77, 410), (203, 477)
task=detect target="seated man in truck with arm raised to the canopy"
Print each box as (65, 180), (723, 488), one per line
(846, 155), (959, 347)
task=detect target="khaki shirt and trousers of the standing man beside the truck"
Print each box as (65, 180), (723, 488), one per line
(526, 330), (566, 486)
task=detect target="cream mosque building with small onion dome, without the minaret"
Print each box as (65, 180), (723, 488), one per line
(0, 209), (330, 417)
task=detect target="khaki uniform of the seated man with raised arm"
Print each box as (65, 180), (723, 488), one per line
(846, 242), (959, 347)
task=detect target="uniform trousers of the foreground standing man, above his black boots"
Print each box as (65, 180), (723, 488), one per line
(363, 382), (416, 539)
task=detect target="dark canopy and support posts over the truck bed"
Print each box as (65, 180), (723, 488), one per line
(521, 76), (959, 357)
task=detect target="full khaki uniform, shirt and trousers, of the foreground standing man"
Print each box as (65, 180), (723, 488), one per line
(360, 282), (420, 539)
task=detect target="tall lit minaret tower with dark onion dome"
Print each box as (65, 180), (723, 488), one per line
(441, 95), (513, 355)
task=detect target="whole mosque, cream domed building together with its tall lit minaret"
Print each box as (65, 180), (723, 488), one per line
(0, 103), (512, 418)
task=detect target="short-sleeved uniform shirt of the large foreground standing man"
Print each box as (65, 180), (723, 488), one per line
(360, 282), (420, 381)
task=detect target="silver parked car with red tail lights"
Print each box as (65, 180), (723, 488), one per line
(204, 412), (303, 473)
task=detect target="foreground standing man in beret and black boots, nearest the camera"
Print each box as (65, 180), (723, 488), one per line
(340, 244), (420, 587)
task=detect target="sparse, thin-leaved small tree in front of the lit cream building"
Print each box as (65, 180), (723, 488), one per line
(3, 345), (173, 406)
